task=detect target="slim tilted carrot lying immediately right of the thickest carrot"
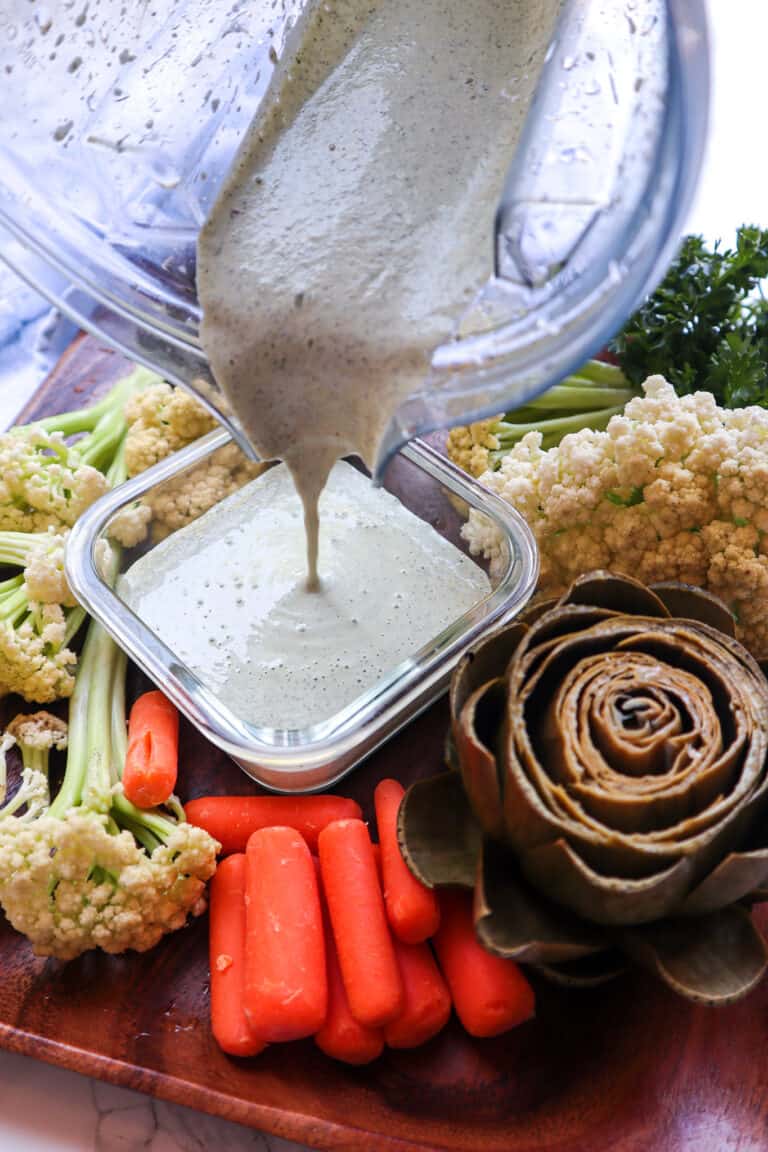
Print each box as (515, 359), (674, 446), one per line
(318, 820), (403, 1028)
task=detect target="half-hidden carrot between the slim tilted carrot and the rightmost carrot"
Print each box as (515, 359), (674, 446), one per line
(385, 939), (450, 1048)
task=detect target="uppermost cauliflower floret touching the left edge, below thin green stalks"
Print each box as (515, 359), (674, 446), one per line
(0, 425), (107, 532)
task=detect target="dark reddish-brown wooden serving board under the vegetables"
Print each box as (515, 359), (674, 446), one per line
(0, 339), (768, 1152)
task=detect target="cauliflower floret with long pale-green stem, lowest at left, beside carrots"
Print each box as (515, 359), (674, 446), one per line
(0, 580), (219, 960)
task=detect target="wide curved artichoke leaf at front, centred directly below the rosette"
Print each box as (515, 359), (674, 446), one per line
(520, 840), (693, 925)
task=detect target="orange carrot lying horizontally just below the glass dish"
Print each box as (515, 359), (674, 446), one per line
(184, 796), (360, 856)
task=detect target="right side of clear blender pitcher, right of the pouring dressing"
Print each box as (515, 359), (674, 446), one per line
(375, 0), (709, 476)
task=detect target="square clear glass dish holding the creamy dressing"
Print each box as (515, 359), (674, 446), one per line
(66, 431), (538, 793)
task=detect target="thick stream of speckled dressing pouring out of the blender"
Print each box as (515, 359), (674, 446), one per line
(197, 0), (560, 586)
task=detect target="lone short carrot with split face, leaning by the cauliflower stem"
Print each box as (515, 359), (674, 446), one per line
(123, 691), (178, 808)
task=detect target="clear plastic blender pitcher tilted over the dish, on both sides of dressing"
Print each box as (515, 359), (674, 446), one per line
(0, 0), (708, 464)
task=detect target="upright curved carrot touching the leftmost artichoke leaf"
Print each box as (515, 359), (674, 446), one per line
(373, 780), (440, 943)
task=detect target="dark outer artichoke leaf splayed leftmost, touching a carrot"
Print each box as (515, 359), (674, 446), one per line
(397, 772), (482, 888)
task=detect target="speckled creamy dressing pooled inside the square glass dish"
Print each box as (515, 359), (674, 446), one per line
(120, 463), (491, 728)
